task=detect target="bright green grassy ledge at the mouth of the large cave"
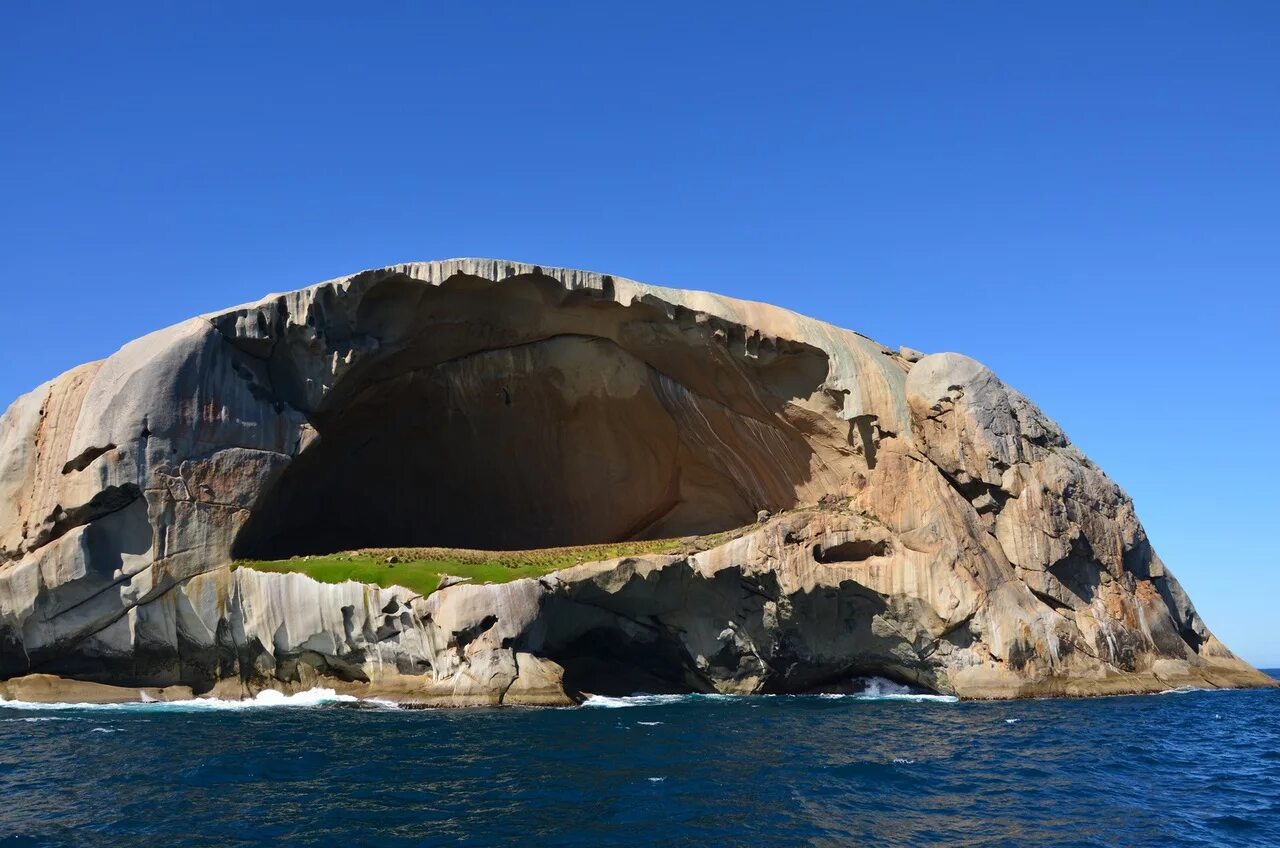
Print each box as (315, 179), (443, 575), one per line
(232, 528), (746, 594)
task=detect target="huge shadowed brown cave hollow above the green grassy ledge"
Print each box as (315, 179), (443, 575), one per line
(234, 277), (827, 559)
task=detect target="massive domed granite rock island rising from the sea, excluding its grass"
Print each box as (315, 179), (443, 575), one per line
(0, 260), (1270, 705)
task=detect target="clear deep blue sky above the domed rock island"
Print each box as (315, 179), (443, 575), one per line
(0, 1), (1280, 666)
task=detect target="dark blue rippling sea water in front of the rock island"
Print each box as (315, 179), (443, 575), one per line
(0, 676), (1280, 848)
